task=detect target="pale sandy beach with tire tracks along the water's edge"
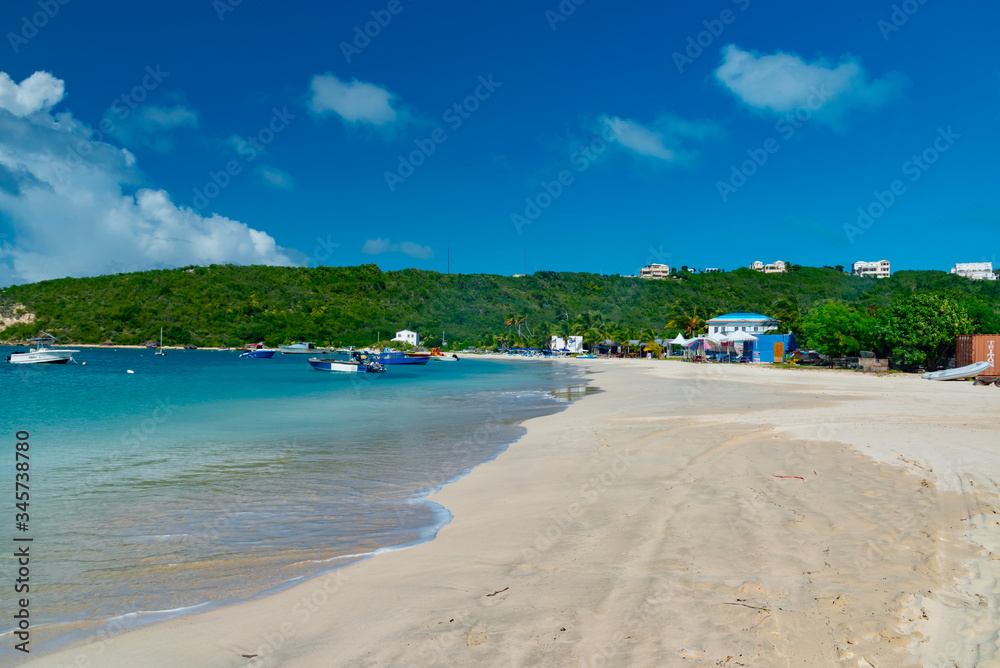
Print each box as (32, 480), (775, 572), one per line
(26, 360), (1000, 667)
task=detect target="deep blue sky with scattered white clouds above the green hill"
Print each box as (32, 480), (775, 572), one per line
(0, 0), (1000, 286)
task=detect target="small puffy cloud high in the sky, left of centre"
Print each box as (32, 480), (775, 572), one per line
(309, 73), (406, 126)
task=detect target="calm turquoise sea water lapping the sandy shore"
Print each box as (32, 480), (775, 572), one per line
(0, 348), (582, 658)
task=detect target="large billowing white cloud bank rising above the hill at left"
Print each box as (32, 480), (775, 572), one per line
(0, 70), (305, 284)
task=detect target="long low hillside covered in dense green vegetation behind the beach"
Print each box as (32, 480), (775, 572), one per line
(0, 265), (1000, 346)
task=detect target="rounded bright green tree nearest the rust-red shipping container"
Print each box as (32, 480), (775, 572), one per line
(872, 293), (975, 371)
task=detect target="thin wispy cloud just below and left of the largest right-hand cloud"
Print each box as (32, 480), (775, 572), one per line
(598, 115), (718, 163)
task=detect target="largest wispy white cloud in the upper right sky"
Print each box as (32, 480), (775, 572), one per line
(715, 44), (904, 118)
